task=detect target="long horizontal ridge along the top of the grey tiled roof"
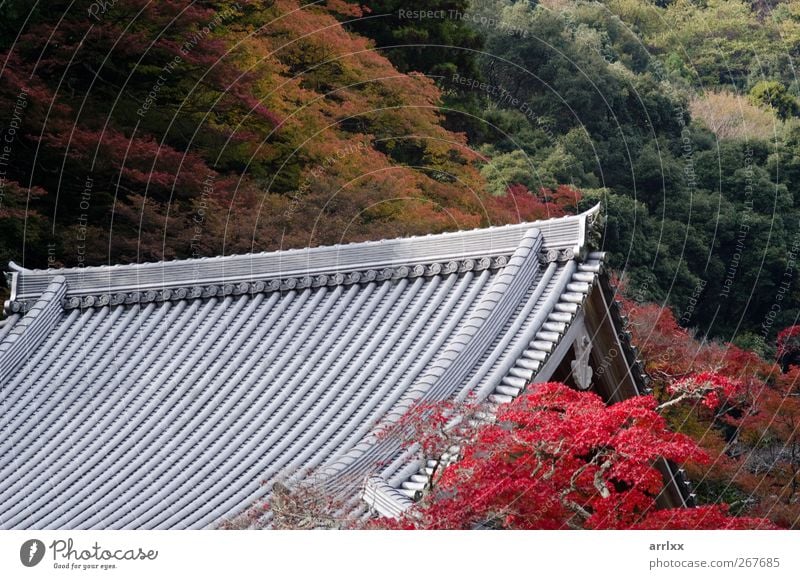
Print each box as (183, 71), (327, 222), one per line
(6, 204), (600, 313)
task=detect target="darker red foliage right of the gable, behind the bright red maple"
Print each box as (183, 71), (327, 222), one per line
(617, 280), (800, 528)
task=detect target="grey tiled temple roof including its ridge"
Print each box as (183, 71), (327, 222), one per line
(0, 208), (602, 529)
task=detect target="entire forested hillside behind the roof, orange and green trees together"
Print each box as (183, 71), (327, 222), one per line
(6, 0), (800, 342)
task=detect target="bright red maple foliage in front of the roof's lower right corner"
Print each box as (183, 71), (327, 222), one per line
(378, 383), (771, 529)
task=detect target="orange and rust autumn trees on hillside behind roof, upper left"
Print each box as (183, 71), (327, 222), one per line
(0, 0), (574, 276)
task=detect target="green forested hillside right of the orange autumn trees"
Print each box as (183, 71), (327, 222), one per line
(350, 0), (800, 348)
